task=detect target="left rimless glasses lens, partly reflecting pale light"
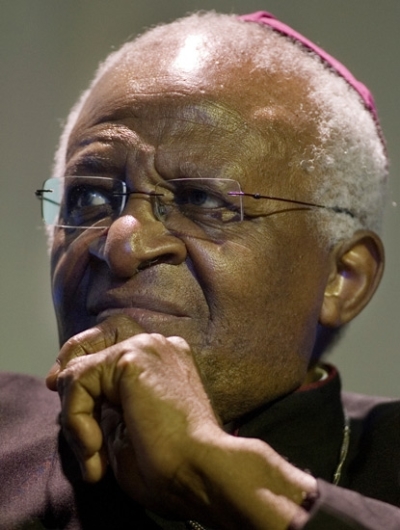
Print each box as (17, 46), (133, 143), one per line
(42, 177), (126, 228)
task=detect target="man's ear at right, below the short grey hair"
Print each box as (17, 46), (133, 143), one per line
(319, 230), (385, 328)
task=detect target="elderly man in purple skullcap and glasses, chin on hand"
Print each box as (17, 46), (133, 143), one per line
(0, 9), (400, 529)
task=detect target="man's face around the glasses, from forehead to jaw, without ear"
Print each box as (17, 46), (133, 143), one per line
(52, 35), (328, 421)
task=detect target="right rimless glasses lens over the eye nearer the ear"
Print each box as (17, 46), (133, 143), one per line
(155, 178), (243, 236)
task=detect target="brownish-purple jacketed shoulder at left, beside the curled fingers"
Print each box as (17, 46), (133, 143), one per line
(0, 372), (67, 528)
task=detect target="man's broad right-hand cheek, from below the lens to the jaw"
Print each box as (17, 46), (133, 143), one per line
(184, 222), (325, 421)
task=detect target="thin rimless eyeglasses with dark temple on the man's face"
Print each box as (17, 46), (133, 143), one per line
(36, 176), (354, 235)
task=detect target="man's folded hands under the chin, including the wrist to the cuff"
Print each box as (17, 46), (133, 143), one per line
(53, 320), (316, 529)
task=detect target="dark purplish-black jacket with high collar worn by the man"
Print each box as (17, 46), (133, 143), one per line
(0, 369), (400, 530)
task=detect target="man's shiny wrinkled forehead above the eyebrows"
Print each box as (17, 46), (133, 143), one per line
(68, 29), (313, 190)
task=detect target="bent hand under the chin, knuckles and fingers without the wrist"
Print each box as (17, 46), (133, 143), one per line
(57, 328), (226, 515)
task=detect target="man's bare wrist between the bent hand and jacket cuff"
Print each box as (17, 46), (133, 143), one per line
(180, 430), (317, 529)
